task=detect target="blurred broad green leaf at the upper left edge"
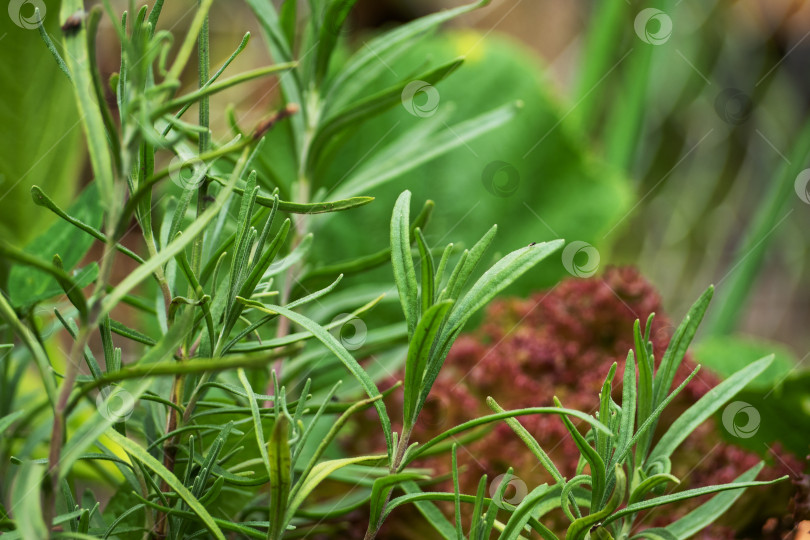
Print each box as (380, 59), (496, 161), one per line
(0, 2), (81, 244)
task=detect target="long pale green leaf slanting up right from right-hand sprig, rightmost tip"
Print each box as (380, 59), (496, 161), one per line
(648, 355), (773, 462)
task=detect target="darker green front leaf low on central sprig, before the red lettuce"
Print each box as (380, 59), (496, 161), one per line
(403, 300), (453, 429)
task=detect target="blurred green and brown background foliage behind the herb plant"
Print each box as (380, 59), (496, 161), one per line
(0, 0), (810, 490)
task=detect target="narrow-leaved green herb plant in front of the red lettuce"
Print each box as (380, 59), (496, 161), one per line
(0, 0), (784, 539)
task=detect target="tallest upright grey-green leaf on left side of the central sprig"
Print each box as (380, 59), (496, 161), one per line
(391, 190), (419, 337)
